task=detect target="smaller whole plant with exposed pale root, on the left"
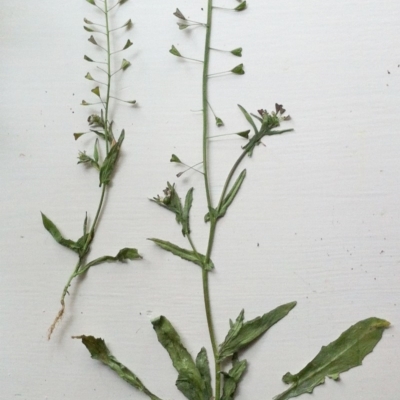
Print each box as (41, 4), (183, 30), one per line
(42, 0), (141, 339)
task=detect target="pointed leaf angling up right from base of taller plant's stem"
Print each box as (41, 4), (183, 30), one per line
(218, 301), (296, 362)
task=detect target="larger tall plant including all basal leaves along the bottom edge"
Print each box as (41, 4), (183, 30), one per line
(77, 0), (390, 400)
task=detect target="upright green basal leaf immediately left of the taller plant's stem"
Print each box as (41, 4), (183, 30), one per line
(151, 316), (205, 400)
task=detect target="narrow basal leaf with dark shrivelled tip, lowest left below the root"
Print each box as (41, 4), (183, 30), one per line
(75, 335), (160, 400)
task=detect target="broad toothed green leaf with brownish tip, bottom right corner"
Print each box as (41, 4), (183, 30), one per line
(274, 318), (390, 400)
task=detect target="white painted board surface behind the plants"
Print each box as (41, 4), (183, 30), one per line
(0, 0), (400, 400)
